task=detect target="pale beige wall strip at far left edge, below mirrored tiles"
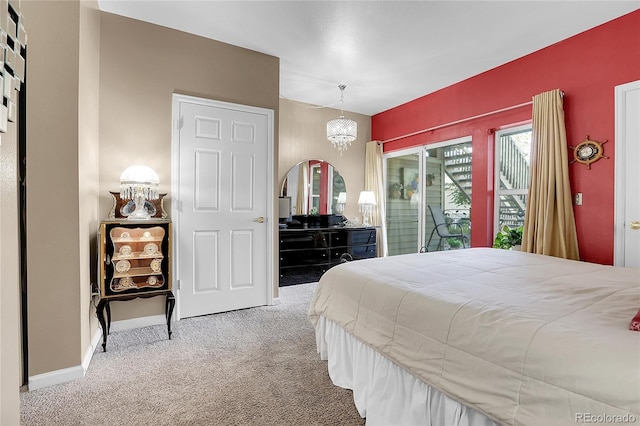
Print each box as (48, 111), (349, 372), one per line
(0, 90), (21, 425)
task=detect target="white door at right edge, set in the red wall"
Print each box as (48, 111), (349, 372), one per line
(615, 81), (640, 268)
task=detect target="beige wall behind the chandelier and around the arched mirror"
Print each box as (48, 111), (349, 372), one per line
(277, 99), (371, 220)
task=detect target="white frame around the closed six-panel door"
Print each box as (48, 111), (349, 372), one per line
(171, 93), (278, 321)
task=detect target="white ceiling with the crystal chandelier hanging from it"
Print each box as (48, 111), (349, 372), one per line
(98, 0), (640, 115)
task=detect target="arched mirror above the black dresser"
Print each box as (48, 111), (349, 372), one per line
(280, 160), (347, 215)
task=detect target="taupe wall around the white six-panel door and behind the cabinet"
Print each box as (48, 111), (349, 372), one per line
(100, 13), (280, 320)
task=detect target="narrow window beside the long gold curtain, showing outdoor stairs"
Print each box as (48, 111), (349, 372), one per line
(494, 124), (531, 234)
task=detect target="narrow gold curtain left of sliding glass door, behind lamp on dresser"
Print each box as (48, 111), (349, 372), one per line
(364, 141), (387, 257)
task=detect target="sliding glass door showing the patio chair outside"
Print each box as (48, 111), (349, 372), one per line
(385, 137), (472, 256)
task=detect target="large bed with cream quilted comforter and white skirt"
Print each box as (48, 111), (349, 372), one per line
(309, 248), (640, 426)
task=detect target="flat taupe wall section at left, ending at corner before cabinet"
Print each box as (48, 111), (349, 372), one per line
(22, 1), (89, 377)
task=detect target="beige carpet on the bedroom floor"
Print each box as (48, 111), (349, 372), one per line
(21, 284), (364, 426)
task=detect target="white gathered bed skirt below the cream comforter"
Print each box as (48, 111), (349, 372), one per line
(316, 316), (497, 426)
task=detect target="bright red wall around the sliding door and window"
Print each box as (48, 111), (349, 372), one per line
(371, 10), (640, 265)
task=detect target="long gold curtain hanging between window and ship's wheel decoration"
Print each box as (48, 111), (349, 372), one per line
(522, 89), (580, 260)
